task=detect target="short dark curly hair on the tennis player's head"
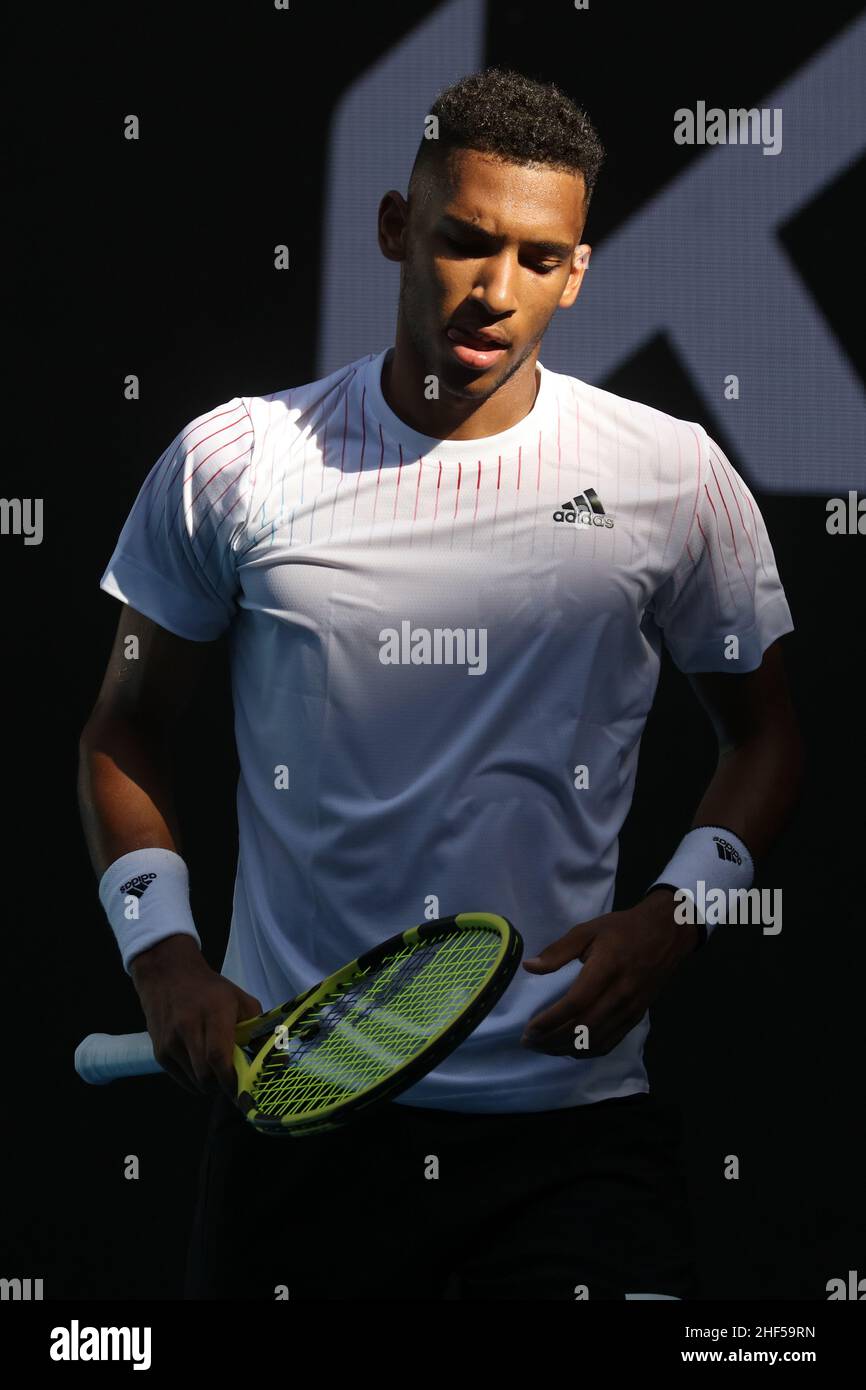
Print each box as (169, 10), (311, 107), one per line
(409, 68), (605, 213)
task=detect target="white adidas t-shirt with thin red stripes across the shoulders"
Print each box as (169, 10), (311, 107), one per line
(101, 349), (792, 1111)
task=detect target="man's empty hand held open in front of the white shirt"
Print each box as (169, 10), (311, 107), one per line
(521, 888), (698, 1062)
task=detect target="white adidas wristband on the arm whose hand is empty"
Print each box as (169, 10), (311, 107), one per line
(646, 826), (755, 935)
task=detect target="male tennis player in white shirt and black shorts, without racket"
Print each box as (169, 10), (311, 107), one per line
(82, 70), (799, 1300)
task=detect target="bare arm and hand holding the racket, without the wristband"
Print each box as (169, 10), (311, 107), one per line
(78, 605), (261, 1098)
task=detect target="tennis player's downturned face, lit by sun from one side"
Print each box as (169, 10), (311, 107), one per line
(395, 150), (589, 402)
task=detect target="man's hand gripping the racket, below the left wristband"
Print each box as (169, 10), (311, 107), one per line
(129, 934), (261, 1101)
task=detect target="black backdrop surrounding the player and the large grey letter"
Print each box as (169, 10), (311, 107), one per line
(0, 0), (866, 1300)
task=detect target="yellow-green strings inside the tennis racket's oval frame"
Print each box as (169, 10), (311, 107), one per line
(253, 929), (502, 1116)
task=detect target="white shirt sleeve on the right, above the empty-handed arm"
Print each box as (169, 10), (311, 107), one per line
(651, 427), (794, 671)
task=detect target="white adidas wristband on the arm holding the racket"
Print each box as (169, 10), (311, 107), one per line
(99, 849), (202, 974)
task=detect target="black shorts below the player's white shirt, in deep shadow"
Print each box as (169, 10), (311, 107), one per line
(185, 1093), (698, 1301)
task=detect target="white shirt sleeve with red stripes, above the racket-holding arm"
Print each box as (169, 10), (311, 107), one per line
(100, 398), (254, 642)
